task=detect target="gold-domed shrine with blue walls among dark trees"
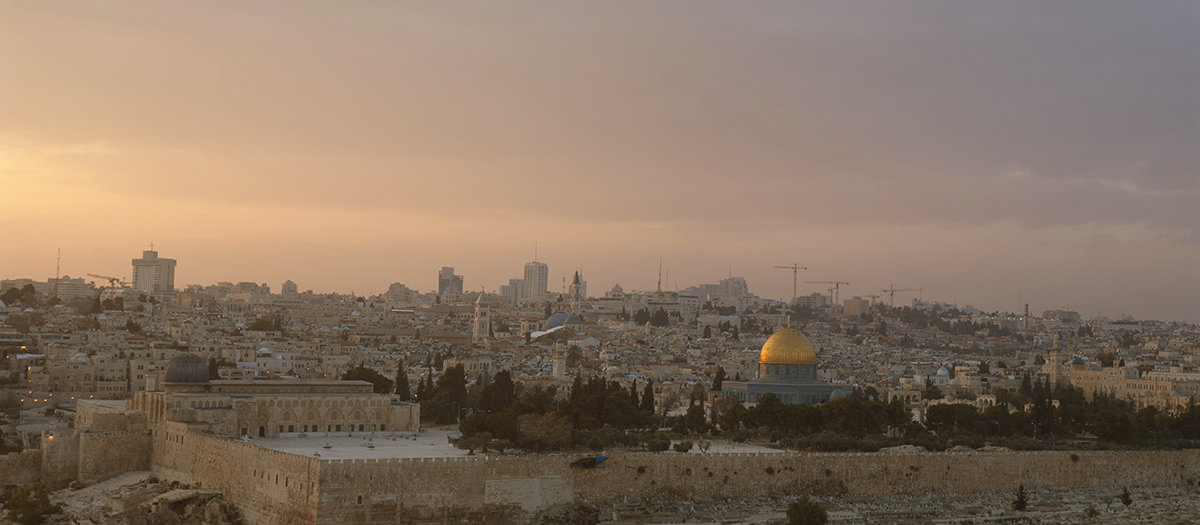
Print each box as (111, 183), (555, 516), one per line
(721, 318), (850, 405)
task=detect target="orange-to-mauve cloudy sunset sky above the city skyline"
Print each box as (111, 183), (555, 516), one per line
(0, 0), (1200, 321)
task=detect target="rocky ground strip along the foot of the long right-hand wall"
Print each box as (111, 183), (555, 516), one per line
(564, 487), (1200, 525)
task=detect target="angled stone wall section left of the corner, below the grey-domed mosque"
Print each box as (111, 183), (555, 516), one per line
(151, 422), (319, 524)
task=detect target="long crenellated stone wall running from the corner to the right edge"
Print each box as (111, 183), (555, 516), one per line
(317, 451), (1200, 524)
